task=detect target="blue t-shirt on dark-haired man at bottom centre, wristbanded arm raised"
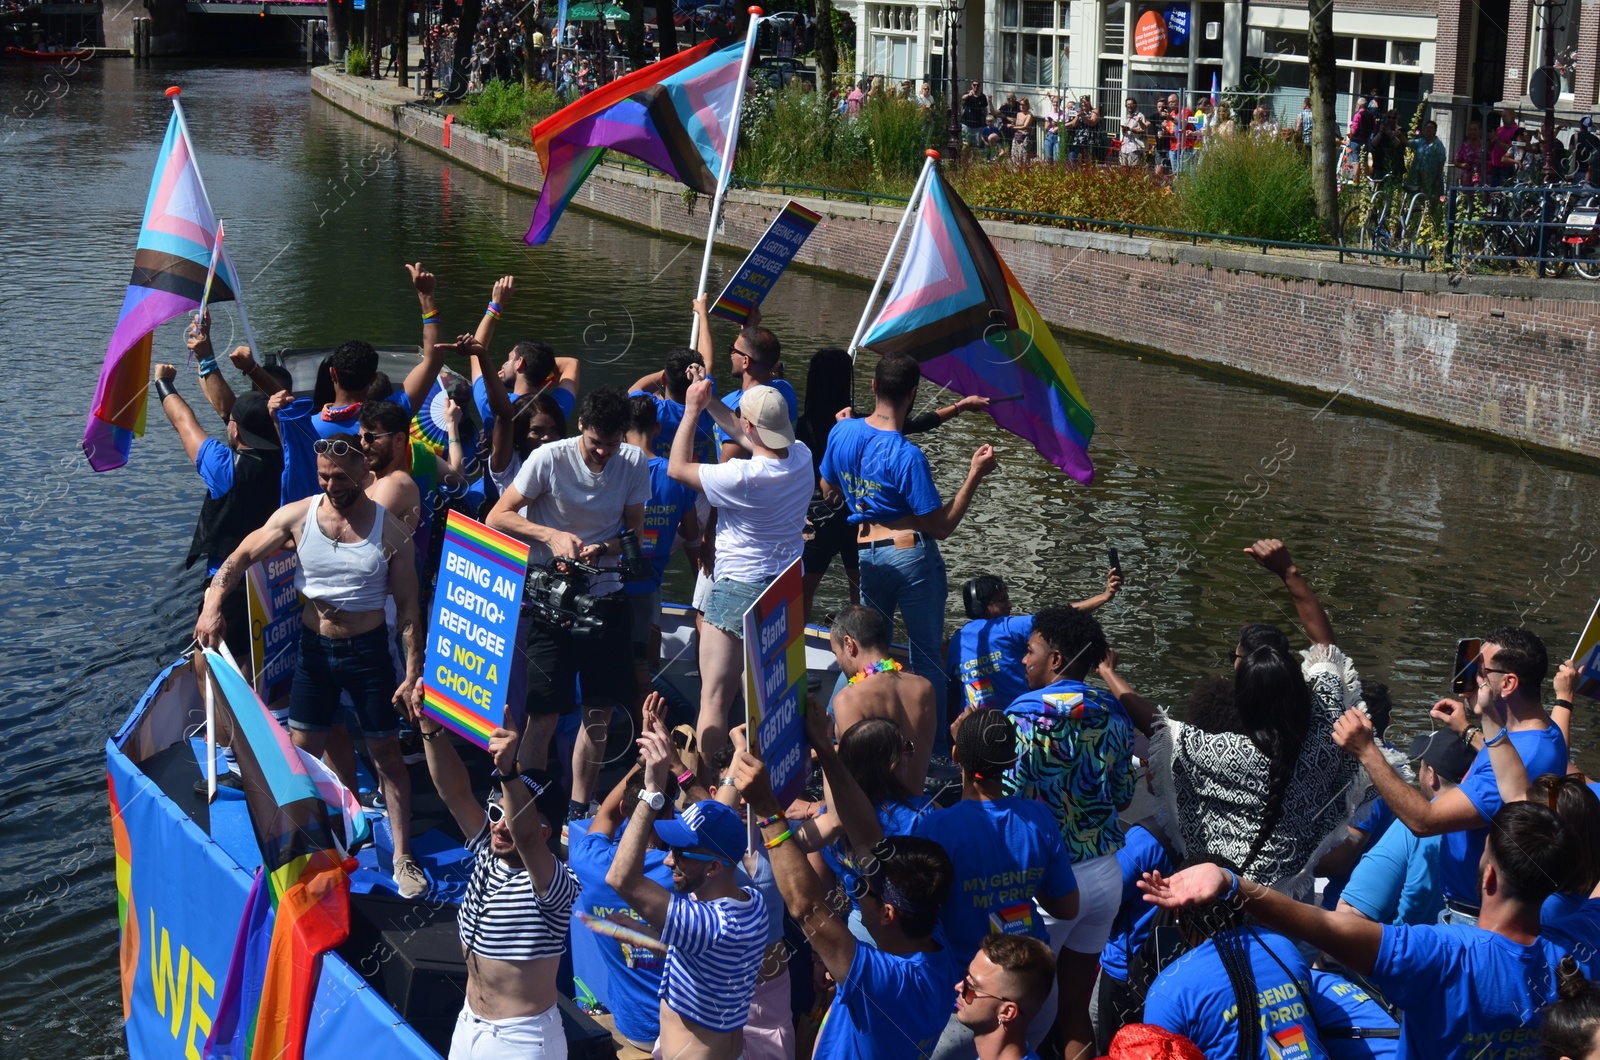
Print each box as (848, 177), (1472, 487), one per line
(811, 932), (947, 1060)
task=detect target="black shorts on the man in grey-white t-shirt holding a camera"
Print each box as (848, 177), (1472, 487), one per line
(523, 592), (638, 716)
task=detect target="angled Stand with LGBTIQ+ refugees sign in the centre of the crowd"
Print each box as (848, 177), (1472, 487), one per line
(744, 559), (811, 805)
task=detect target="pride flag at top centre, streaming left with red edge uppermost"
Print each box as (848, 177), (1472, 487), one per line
(525, 40), (744, 247)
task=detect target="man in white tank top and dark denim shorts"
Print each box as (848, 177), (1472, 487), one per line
(195, 434), (427, 898)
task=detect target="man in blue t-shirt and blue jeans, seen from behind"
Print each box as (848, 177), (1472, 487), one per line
(819, 354), (997, 743)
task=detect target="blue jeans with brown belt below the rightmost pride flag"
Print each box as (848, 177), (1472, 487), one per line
(861, 535), (950, 749)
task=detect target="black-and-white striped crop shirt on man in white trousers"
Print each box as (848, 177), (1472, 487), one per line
(459, 818), (579, 961)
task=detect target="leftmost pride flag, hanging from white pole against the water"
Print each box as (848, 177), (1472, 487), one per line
(83, 99), (238, 471)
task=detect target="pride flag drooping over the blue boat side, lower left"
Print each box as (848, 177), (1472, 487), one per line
(203, 652), (366, 1060)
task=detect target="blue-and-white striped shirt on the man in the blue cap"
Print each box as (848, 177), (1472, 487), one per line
(656, 887), (766, 1031)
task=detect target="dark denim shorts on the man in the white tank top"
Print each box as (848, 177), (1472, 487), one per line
(290, 626), (400, 740)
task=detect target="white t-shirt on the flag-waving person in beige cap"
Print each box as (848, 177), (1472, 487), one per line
(701, 442), (816, 583)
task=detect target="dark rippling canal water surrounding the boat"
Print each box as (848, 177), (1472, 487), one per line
(0, 59), (1600, 1057)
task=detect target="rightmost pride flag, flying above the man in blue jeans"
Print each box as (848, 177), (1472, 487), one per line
(861, 167), (1094, 485)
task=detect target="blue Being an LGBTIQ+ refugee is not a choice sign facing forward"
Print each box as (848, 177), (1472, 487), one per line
(422, 511), (528, 749)
